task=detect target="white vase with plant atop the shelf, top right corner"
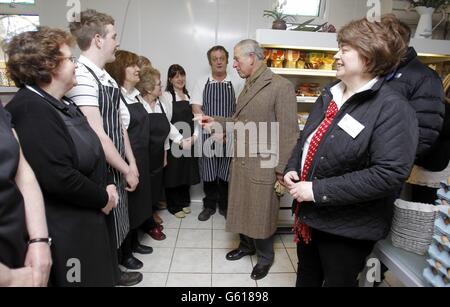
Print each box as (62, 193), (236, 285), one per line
(409, 0), (449, 38)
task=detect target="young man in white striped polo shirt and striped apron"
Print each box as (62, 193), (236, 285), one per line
(66, 10), (143, 286)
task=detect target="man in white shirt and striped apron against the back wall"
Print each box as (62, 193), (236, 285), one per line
(191, 46), (243, 221)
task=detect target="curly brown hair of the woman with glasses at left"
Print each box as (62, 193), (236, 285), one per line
(5, 27), (75, 87)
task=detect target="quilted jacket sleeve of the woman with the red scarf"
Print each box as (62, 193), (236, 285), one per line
(313, 95), (418, 206)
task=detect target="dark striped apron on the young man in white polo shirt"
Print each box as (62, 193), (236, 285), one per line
(84, 65), (130, 248)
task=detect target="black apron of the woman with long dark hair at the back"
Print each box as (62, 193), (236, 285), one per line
(164, 95), (200, 188)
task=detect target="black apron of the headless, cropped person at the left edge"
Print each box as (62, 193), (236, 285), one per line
(0, 102), (27, 268)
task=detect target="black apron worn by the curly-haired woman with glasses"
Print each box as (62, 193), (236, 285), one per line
(34, 87), (118, 287)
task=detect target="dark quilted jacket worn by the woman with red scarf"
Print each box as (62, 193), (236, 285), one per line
(286, 80), (418, 240)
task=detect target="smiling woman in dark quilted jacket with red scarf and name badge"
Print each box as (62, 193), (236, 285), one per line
(284, 19), (418, 287)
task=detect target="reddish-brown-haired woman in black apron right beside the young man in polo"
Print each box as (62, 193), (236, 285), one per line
(105, 50), (153, 270)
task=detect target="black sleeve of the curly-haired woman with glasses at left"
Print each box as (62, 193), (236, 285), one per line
(12, 100), (108, 209)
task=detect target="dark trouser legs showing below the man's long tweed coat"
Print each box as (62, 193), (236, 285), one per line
(239, 234), (275, 265)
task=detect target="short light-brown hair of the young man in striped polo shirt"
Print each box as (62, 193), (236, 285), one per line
(69, 10), (115, 51)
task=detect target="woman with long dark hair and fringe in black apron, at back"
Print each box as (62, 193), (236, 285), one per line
(164, 65), (200, 215)
